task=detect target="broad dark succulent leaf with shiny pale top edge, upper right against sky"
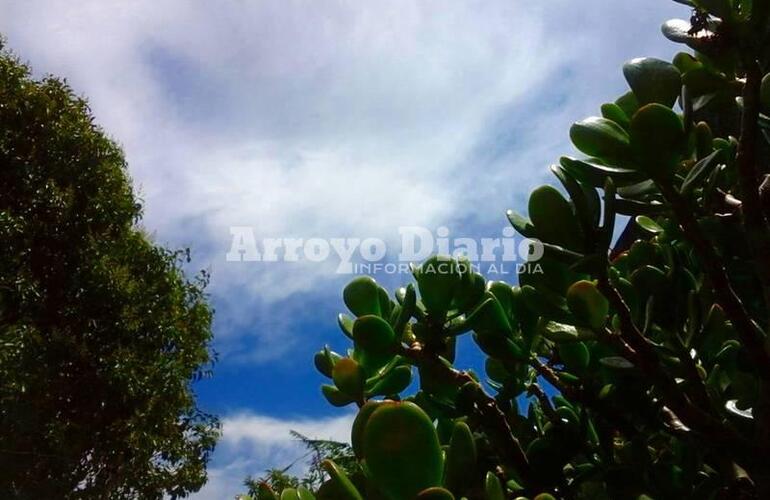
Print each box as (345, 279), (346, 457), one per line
(623, 57), (682, 108)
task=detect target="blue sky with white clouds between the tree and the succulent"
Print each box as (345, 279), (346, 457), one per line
(0, 0), (689, 500)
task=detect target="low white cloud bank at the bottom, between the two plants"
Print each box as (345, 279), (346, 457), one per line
(196, 413), (354, 500)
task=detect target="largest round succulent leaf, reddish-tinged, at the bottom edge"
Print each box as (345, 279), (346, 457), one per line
(363, 401), (444, 500)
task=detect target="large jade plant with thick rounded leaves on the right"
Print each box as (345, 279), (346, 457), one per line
(261, 0), (770, 500)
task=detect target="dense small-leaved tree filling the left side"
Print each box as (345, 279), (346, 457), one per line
(0, 44), (219, 499)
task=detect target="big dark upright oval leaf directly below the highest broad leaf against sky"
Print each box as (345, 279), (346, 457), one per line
(631, 104), (687, 179)
